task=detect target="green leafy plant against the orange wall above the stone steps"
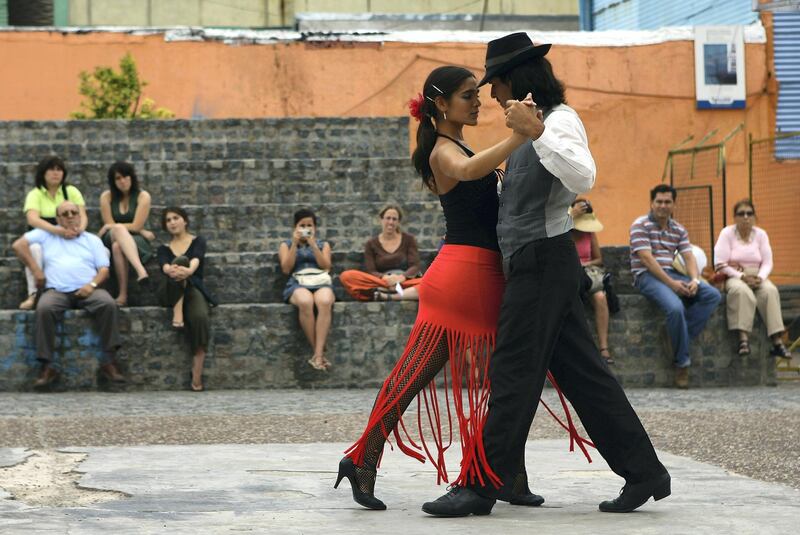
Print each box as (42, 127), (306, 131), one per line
(70, 53), (175, 119)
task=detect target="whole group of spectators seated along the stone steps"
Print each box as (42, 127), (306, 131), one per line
(7, 156), (790, 392)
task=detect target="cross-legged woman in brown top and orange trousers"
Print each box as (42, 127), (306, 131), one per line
(339, 205), (422, 301)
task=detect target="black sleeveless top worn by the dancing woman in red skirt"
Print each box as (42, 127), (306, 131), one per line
(436, 132), (500, 251)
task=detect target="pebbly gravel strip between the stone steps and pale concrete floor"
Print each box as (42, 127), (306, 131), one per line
(0, 384), (800, 489)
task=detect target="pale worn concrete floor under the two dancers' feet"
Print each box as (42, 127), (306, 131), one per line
(0, 440), (800, 535)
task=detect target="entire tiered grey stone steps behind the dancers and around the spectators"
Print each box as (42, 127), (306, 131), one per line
(0, 118), (775, 391)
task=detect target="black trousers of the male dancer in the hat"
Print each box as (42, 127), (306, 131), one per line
(474, 234), (665, 498)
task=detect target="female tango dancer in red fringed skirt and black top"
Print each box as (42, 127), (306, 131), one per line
(335, 67), (541, 509)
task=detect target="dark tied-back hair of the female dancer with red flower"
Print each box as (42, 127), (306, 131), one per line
(411, 66), (475, 192)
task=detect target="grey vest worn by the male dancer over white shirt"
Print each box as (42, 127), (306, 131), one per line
(497, 104), (577, 260)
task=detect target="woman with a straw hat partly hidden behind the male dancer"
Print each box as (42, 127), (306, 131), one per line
(570, 199), (614, 364)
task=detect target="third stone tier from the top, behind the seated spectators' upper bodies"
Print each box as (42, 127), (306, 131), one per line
(0, 203), (444, 256)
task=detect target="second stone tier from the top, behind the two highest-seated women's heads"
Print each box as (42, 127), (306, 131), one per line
(0, 157), (424, 208)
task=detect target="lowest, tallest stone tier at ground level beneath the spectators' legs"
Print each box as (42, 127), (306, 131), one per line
(0, 295), (775, 391)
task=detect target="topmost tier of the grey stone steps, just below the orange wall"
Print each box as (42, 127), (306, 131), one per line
(0, 117), (409, 162)
